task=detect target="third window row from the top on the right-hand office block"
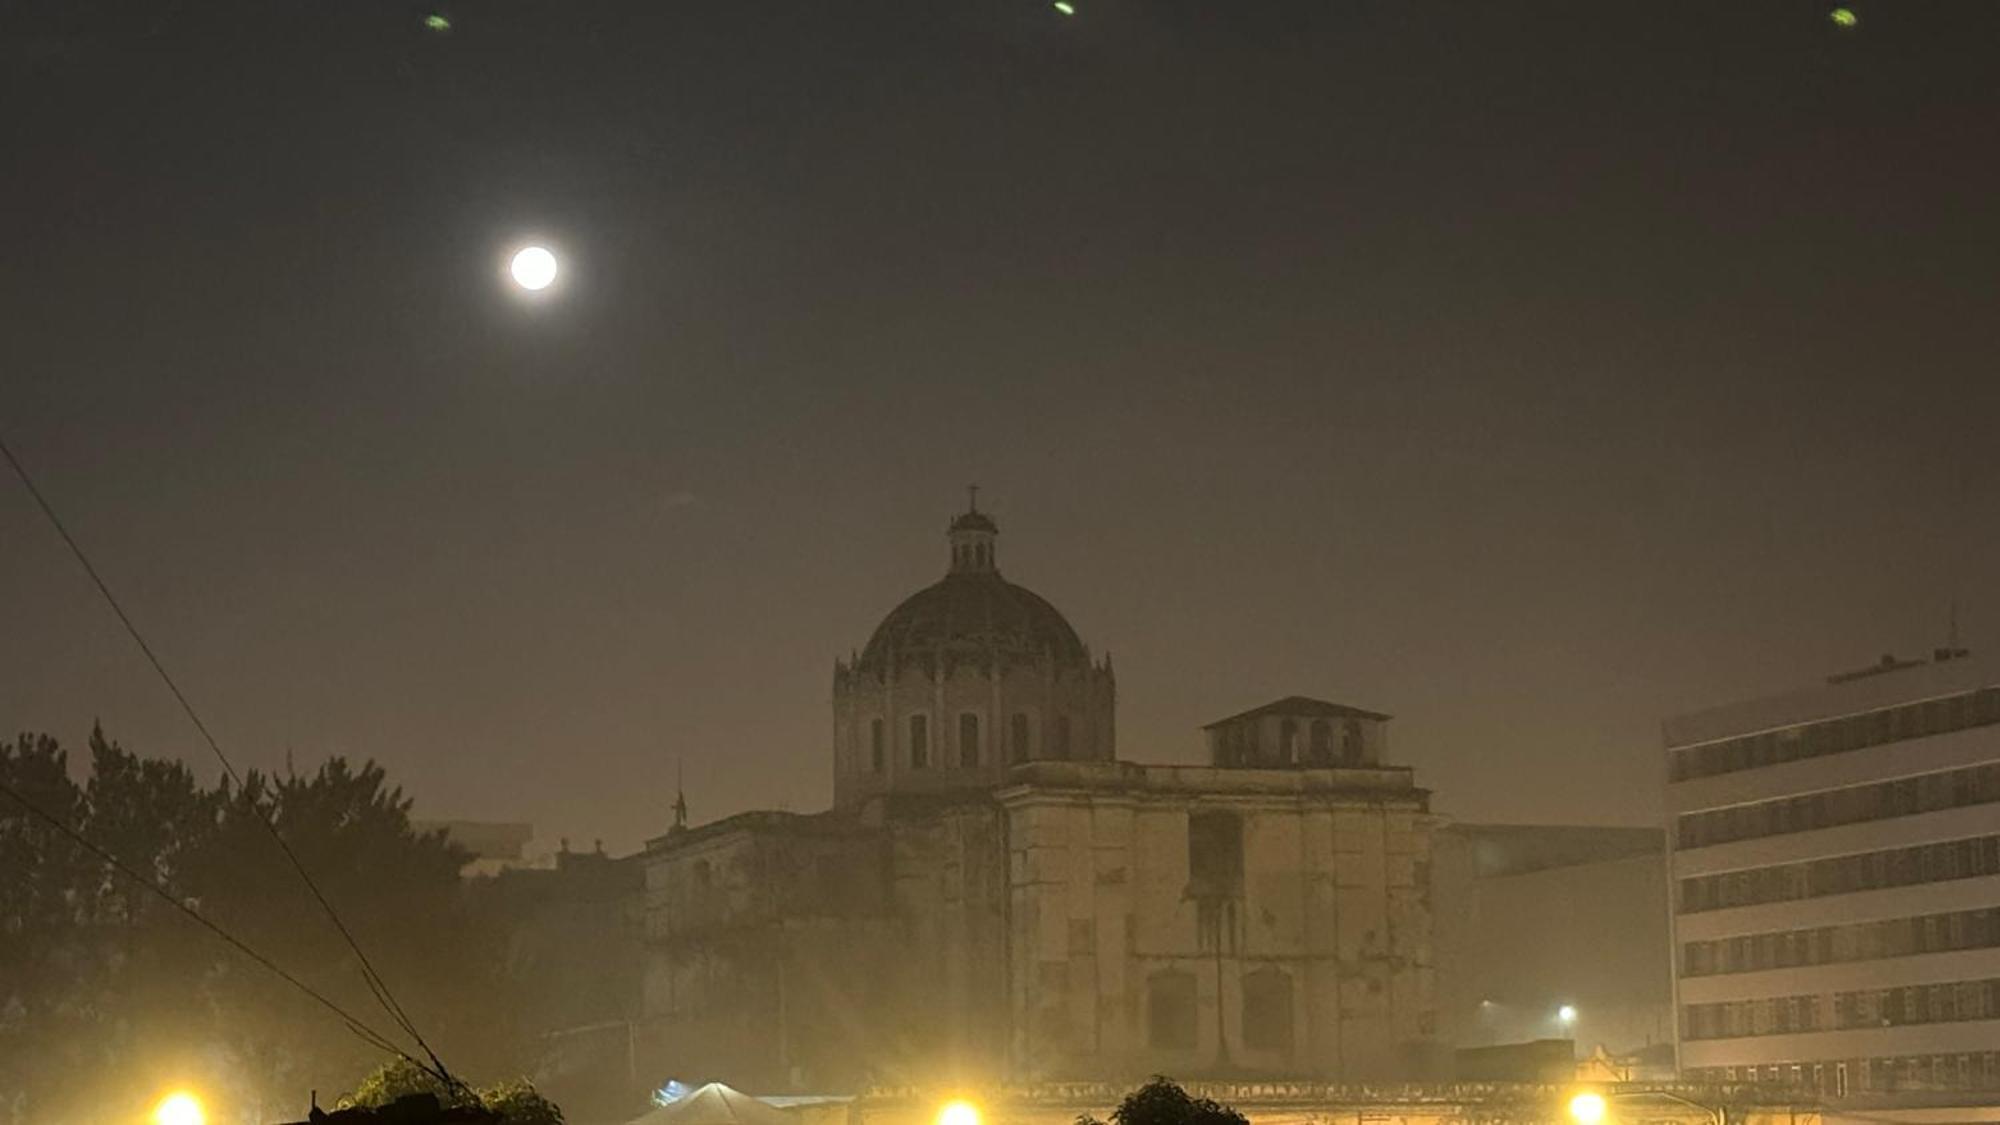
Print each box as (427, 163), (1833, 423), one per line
(1680, 837), (2000, 915)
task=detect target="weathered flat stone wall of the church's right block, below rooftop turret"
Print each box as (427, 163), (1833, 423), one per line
(1002, 765), (1436, 1079)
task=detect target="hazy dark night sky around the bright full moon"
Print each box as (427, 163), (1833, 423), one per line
(0, 0), (2000, 851)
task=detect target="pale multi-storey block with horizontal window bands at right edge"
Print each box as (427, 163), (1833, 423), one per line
(1666, 649), (2000, 1121)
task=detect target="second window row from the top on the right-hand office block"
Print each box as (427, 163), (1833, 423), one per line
(1676, 763), (2000, 847)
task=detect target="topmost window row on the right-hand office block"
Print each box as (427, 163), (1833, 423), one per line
(1668, 687), (2000, 781)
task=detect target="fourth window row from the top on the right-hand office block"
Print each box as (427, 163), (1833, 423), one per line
(1680, 907), (2000, 977)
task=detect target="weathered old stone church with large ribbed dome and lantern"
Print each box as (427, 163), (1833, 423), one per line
(632, 506), (1440, 1093)
